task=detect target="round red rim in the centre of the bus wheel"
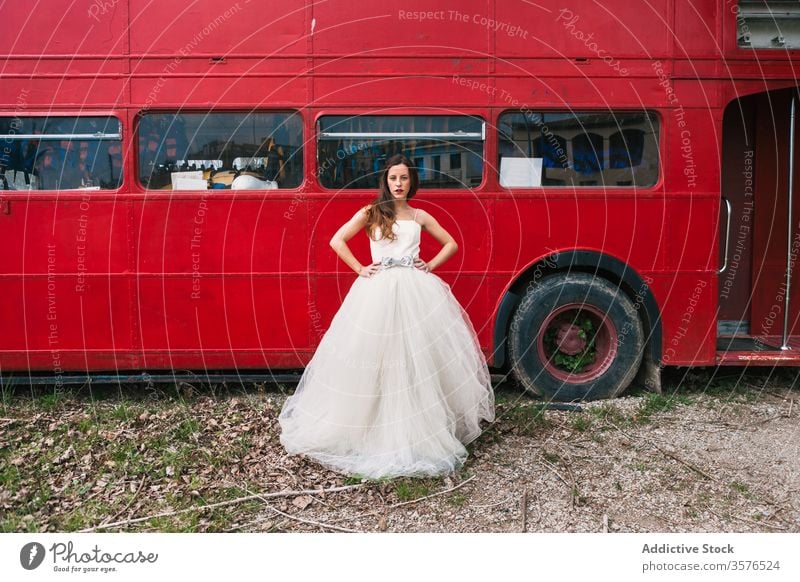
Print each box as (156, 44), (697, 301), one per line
(536, 303), (618, 384)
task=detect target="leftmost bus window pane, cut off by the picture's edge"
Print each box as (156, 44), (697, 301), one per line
(0, 116), (122, 190)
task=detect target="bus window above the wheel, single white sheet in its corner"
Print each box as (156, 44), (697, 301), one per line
(498, 110), (659, 188)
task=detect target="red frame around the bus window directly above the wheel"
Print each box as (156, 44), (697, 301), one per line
(493, 107), (666, 194)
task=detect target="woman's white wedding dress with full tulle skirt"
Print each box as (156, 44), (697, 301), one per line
(279, 220), (494, 478)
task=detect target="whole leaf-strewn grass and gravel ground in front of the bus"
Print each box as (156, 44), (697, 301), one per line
(0, 368), (800, 532)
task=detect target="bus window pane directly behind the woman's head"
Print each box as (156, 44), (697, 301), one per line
(317, 115), (485, 189)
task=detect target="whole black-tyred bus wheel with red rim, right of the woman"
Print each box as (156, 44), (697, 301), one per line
(508, 273), (644, 401)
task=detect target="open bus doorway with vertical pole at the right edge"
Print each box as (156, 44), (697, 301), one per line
(717, 90), (800, 353)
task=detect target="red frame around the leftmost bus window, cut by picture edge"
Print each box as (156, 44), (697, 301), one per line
(0, 109), (125, 199)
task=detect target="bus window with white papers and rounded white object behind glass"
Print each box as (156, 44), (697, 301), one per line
(137, 111), (303, 190)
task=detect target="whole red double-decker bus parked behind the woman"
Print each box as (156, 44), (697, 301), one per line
(0, 0), (800, 400)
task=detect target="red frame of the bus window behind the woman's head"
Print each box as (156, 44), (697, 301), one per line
(311, 107), (492, 197)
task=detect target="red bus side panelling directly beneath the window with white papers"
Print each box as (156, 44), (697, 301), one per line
(134, 194), (309, 366)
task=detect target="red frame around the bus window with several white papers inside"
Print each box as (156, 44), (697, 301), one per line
(131, 107), (308, 198)
